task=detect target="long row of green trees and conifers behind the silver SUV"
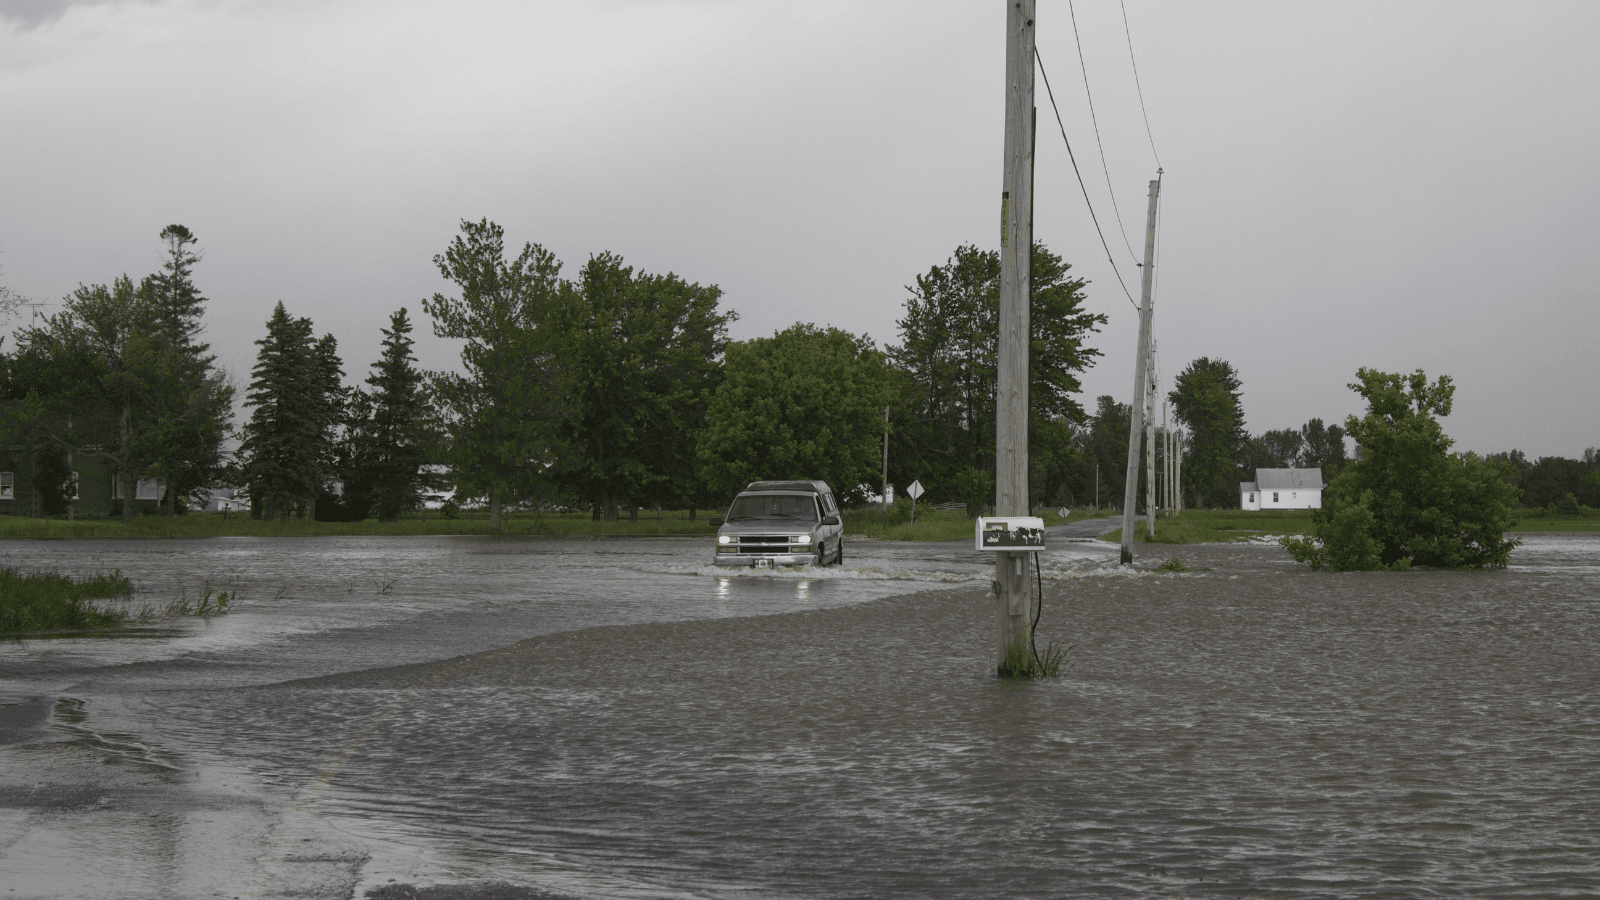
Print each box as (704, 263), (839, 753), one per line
(0, 219), (1106, 527)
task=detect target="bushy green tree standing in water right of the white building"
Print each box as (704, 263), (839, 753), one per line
(1283, 368), (1520, 572)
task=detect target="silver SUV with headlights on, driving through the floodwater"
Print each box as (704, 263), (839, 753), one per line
(712, 482), (845, 567)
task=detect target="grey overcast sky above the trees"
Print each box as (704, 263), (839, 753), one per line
(0, 0), (1600, 456)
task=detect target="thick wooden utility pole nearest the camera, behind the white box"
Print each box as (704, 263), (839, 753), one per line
(995, 0), (1035, 668)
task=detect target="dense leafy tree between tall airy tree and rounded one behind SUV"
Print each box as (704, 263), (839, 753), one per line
(557, 253), (734, 520)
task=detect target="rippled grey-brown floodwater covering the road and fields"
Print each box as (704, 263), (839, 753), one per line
(0, 535), (1600, 898)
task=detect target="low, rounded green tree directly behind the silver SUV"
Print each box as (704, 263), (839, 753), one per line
(698, 323), (890, 501)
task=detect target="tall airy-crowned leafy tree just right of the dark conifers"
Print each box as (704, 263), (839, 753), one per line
(422, 219), (568, 532)
